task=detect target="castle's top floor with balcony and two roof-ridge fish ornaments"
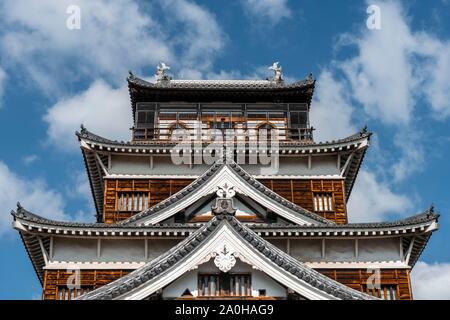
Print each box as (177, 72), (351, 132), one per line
(128, 64), (315, 143)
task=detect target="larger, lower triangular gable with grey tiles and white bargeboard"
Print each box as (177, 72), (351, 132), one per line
(80, 214), (371, 300)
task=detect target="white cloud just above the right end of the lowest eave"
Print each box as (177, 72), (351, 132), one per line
(347, 170), (413, 222)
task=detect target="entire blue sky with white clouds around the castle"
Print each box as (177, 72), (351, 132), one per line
(0, 0), (450, 299)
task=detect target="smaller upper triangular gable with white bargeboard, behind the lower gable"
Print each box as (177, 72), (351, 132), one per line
(119, 160), (334, 225)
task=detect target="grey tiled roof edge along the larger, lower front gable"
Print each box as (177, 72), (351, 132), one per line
(79, 215), (372, 300)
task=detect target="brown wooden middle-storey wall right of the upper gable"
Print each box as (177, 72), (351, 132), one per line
(260, 179), (347, 224)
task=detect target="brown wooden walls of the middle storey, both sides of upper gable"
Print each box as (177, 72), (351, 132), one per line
(103, 179), (347, 224)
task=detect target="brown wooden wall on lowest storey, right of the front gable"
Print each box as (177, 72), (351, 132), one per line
(317, 269), (413, 300)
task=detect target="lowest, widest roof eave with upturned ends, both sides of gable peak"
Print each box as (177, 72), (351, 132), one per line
(11, 204), (439, 282)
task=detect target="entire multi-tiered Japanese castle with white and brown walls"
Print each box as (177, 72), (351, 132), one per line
(12, 63), (439, 300)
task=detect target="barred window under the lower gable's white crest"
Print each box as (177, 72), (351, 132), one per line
(198, 273), (252, 297)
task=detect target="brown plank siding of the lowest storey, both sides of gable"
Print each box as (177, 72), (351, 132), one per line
(42, 269), (412, 300)
